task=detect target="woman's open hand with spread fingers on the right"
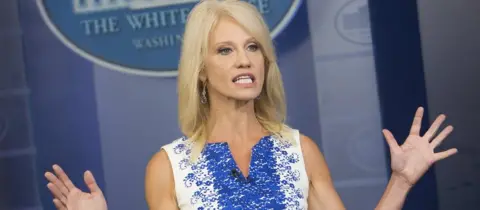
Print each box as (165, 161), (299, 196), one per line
(383, 107), (457, 186)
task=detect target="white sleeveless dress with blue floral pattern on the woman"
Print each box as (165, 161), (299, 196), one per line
(162, 130), (309, 210)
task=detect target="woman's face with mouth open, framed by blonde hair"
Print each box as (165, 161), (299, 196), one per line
(204, 18), (265, 101)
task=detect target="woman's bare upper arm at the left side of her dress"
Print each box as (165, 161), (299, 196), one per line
(145, 150), (178, 210)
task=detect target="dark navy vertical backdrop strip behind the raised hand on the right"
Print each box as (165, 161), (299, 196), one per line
(369, 1), (438, 209)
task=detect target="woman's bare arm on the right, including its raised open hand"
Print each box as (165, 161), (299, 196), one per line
(300, 107), (458, 210)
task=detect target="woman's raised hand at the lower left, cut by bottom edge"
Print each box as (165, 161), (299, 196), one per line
(45, 165), (107, 210)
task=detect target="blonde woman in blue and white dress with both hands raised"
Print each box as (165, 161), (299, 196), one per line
(45, 0), (457, 210)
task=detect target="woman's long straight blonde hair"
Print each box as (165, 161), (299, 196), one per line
(178, 0), (294, 159)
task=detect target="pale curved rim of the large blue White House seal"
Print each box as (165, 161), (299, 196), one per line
(36, 0), (303, 77)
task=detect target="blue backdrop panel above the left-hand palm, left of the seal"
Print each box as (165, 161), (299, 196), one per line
(17, 1), (104, 209)
